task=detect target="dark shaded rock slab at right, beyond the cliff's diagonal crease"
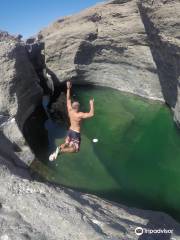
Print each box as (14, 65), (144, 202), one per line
(139, 0), (180, 124)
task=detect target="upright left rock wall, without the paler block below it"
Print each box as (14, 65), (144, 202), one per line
(0, 32), (42, 127)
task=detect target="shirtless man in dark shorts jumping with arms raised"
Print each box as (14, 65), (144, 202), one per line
(49, 81), (94, 161)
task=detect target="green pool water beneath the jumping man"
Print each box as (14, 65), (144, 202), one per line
(37, 87), (180, 219)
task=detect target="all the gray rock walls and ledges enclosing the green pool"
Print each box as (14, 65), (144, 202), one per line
(0, 0), (180, 240)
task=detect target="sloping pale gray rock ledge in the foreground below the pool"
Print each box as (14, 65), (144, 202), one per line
(0, 161), (180, 240)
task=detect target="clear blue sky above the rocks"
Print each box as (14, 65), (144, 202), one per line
(0, 0), (103, 38)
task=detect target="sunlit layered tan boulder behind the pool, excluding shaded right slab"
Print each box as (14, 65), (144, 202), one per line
(40, 0), (164, 101)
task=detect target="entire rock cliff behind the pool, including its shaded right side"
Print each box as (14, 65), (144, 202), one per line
(41, 0), (180, 122)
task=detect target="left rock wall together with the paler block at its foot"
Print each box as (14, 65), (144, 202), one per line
(0, 32), (42, 164)
